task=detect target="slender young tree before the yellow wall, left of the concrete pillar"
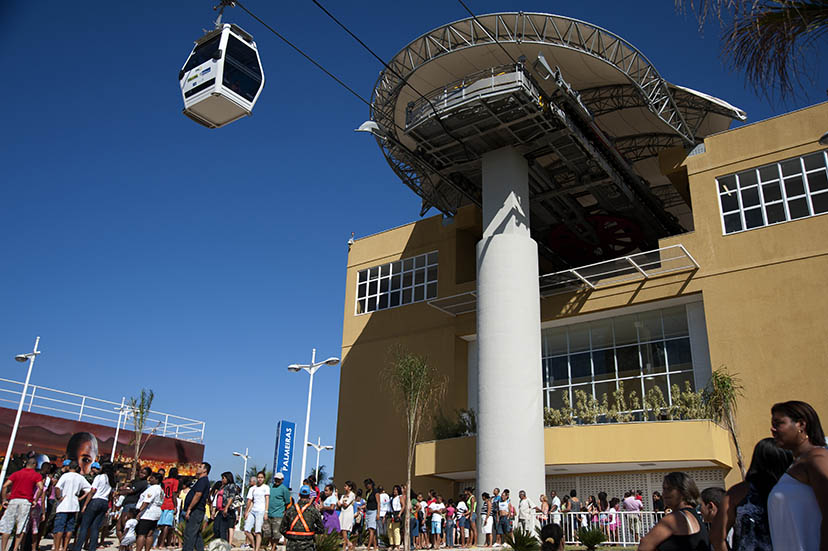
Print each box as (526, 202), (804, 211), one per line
(383, 347), (446, 551)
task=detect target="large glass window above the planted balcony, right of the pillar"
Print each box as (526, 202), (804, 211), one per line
(542, 305), (695, 413)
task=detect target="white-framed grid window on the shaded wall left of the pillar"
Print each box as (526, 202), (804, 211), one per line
(355, 251), (437, 315)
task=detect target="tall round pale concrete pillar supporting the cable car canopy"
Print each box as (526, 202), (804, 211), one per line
(477, 147), (545, 508)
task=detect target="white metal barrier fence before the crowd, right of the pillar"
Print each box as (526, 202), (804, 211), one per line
(537, 511), (665, 546)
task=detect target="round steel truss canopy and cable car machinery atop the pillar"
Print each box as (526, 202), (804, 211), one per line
(371, 13), (744, 269)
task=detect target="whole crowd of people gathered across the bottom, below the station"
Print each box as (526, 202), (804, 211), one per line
(0, 401), (828, 551)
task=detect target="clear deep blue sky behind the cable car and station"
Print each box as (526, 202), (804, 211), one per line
(0, 0), (826, 492)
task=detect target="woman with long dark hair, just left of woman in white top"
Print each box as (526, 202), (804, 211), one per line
(710, 438), (793, 551)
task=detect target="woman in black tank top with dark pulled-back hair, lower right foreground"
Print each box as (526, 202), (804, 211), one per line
(638, 472), (710, 551)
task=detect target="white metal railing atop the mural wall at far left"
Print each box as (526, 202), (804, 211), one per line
(0, 378), (204, 443)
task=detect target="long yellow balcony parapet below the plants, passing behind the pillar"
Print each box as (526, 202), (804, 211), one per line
(414, 420), (733, 480)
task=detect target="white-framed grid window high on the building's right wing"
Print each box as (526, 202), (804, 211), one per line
(716, 150), (828, 235)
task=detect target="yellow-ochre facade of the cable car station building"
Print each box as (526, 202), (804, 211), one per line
(336, 103), (828, 504)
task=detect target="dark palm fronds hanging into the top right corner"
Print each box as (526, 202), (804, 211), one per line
(675, 0), (828, 96)
